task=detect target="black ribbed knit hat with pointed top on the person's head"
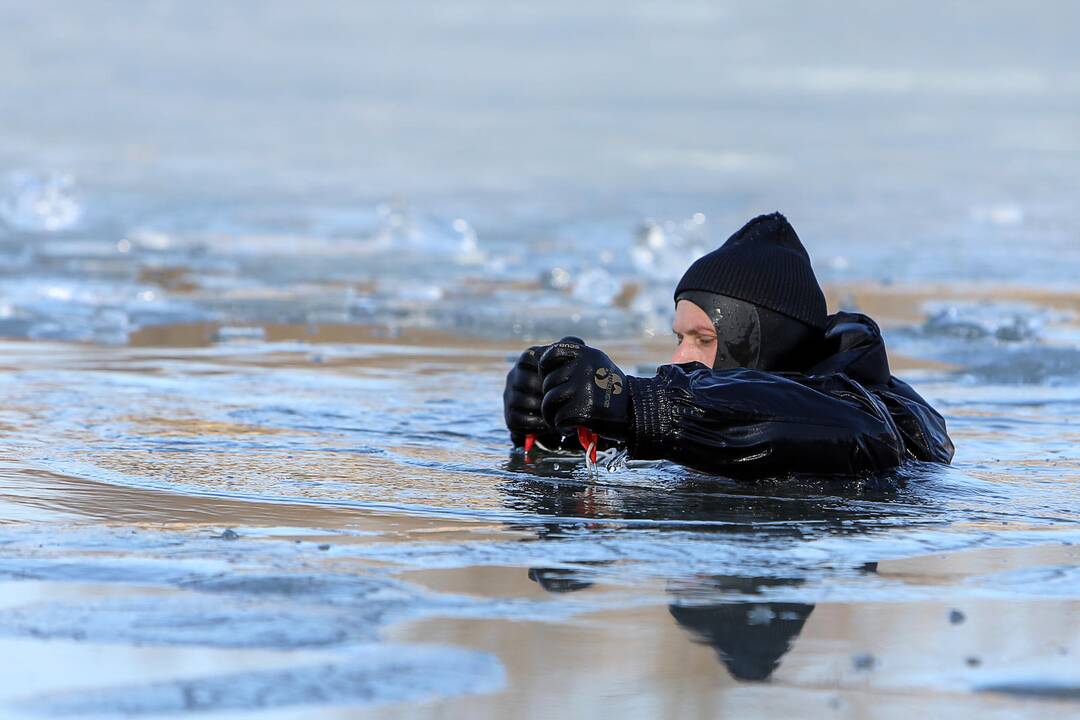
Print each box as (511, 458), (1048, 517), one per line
(675, 213), (827, 329)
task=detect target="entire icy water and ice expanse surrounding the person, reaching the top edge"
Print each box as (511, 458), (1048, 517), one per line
(0, 2), (1080, 718)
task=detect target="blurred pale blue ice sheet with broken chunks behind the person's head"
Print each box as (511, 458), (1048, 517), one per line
(0, 0), (1080, 342)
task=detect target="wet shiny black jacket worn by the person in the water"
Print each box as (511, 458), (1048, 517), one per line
(627, 313), (953, 477)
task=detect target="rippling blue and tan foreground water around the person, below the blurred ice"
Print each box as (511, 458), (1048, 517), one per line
(0, 310), (1080, 717)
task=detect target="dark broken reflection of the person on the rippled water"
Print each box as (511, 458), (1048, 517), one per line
(502, 472), (889, 681)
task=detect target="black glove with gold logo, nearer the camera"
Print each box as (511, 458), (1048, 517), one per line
(540, 338), (633, 440)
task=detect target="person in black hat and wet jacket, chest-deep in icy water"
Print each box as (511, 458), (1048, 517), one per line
(503, 213), (953, 477)
